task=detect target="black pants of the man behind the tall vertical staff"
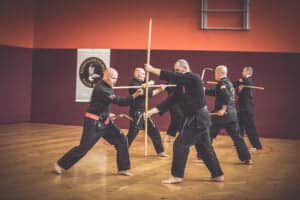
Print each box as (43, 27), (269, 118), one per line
(127, 111), (164, 153)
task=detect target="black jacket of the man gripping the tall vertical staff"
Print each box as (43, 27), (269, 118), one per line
(157, 70), (210, 128)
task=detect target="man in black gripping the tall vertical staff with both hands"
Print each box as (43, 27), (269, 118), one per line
(145, 59), (224, 184)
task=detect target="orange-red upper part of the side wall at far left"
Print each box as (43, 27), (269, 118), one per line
(0, 0), (35, 47)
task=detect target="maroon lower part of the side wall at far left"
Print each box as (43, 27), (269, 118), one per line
(0, 46), (32, 124)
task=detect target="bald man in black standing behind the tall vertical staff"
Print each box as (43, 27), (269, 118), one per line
(127, 68), (168, 157)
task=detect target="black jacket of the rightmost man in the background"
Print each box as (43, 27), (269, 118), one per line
(234, 77), (254, 113)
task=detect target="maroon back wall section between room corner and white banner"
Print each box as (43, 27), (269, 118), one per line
(31, 49), (86, 124)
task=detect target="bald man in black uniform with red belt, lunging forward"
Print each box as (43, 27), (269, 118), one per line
(54, 68), (143, 176)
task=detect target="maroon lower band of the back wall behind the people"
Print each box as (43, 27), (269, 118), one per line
(32, 49), (300, 138)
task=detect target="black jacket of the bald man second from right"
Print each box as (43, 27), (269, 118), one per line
(205, 77), (237, 124)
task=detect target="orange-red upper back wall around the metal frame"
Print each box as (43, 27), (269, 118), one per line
(34, 0), (300, 52)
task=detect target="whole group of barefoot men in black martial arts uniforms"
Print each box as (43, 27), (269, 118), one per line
(54, 59), (262, 184)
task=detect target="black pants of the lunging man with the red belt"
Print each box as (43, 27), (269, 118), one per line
(58, 118), (130, 171)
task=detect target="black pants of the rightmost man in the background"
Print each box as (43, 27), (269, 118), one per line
(238, 112), (262, 149)
